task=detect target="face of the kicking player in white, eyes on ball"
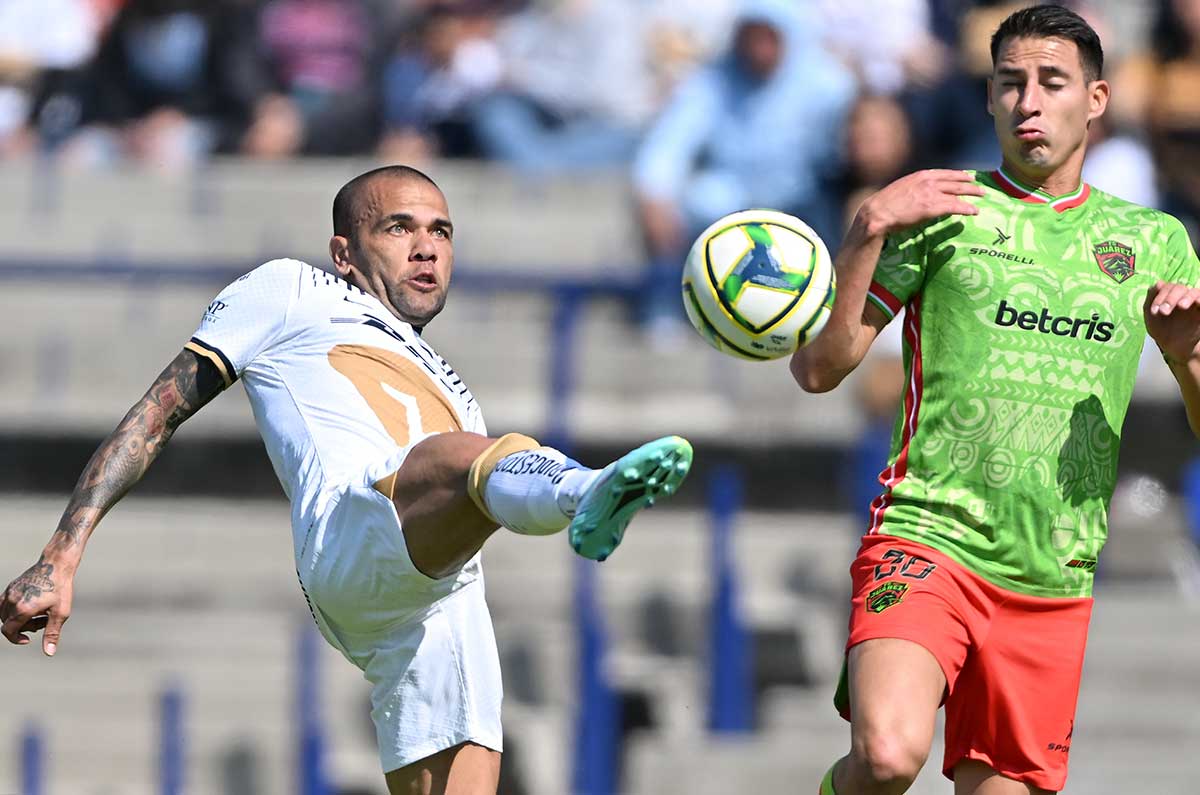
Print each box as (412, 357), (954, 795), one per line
(331, 177), (454, 325)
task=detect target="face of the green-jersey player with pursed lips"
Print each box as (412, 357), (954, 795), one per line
(988, 36), (1109, 177)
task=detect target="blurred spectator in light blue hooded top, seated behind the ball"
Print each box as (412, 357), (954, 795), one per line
(634, 0), (854, 339)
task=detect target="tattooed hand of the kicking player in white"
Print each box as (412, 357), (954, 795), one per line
(0, 556), (74, 657)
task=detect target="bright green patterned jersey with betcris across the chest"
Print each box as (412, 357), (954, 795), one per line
(868, 171), (1200, 597)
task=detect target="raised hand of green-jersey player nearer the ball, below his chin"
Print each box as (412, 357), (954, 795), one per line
(859, 168), (984, 235)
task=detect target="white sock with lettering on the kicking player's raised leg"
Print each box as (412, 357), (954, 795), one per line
(484, 447), (600, 536)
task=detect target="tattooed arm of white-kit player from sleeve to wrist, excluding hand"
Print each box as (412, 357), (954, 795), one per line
(52, 351), (224, 548)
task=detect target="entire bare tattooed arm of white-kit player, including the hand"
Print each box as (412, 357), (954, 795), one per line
(0, 349), (224, 654)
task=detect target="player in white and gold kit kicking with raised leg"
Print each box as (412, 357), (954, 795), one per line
(0, 166), (691, 795)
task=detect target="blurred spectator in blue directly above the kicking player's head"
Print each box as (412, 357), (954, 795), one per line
(379, 0), (502, 162)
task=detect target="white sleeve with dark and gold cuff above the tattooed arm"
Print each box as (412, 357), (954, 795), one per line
(184, 259), (302, 387)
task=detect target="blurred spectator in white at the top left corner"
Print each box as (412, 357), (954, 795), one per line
(0, 0), (104, 157)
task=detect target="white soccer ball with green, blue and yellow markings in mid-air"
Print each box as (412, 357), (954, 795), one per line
(683, 210), (836, 361)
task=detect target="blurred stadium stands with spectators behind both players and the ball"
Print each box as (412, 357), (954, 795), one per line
(0, 0), (1200, 795)
